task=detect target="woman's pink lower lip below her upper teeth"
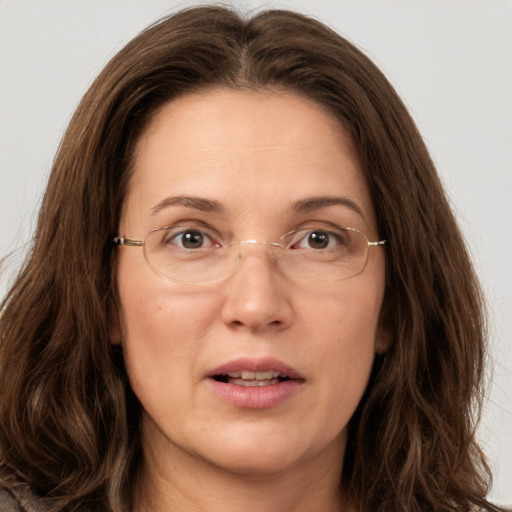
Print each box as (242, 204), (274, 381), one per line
(209, 379), (304, 409)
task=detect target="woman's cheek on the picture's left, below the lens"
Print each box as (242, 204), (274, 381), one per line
(118, 267), (221, 394)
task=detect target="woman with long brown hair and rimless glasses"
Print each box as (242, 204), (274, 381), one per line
(0, 7), (499, 512)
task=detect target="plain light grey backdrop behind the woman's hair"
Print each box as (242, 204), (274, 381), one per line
(0, 0), (512, 503)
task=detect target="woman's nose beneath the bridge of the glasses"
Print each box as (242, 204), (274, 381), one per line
(222, 245), (293, 331)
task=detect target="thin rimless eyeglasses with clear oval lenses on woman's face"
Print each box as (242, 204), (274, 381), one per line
(113, 225), (386, 284)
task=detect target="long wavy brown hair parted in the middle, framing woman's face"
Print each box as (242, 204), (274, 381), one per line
(0, 6), (502, 512)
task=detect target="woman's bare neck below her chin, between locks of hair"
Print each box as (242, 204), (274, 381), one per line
(132, 420), (353, 512)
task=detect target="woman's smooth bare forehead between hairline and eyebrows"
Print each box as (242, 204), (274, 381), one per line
(125, 89), (373, 232)
